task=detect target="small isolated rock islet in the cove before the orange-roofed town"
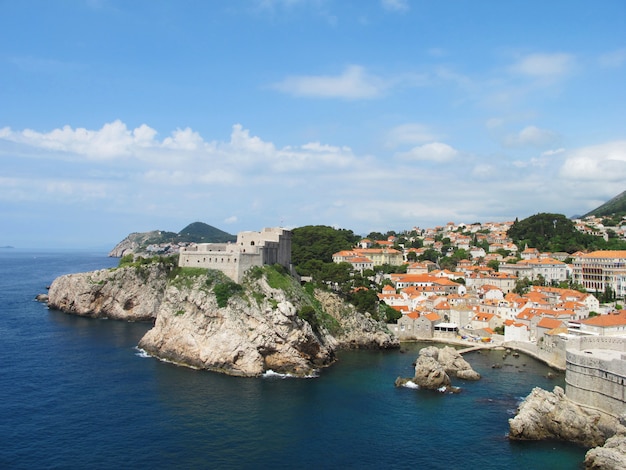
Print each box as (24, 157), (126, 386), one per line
(396, 346), (480, 391)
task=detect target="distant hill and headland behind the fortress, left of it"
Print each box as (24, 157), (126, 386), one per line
(109, 222), (237, 258)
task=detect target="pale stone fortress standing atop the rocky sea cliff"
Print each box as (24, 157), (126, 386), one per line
(178, 227), (292, 282)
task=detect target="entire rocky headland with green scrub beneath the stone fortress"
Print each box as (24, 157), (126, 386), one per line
(49, 264), (399, 376)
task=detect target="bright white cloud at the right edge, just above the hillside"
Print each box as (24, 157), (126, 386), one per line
(560, 140), (626, 183)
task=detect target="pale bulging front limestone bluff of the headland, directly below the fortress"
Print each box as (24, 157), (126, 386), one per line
(139, 272), (334, 376)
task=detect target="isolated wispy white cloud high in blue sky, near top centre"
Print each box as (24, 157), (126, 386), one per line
(274, 65), (388, 100)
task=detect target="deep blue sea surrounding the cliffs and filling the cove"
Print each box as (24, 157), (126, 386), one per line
(0, 249), (586, 470)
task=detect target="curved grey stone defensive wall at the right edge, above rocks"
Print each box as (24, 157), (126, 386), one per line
(565, 336), (626, 418)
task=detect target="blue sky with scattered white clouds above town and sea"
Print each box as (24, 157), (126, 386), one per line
(0, 0), (626, 248)
